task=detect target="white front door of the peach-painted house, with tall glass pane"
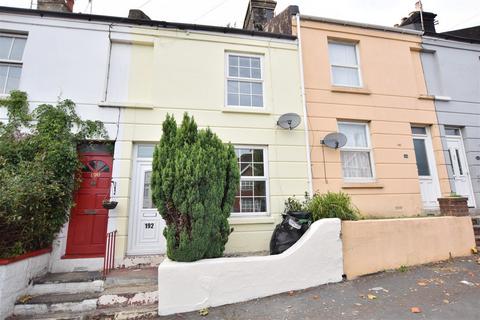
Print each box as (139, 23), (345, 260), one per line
(412, 126), (441, 210)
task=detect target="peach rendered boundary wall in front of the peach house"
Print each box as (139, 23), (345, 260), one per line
(342, 217), (475, 279)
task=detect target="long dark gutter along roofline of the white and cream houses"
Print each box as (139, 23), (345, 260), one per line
(0, 6), (297, 40)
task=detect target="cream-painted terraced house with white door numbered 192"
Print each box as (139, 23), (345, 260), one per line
(105, 27), (308, 262)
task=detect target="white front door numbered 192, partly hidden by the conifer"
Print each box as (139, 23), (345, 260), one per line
(128, 145), (166, 255)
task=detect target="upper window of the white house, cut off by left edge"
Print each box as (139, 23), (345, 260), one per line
(0, 34), (27, 94)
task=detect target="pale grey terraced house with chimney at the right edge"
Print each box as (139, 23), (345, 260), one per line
(403, 11), (480, 208)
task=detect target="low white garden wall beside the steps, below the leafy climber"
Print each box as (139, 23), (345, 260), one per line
(0, 253), (50, 319)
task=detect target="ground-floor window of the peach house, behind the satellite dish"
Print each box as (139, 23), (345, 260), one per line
(338, 122), (374, 181)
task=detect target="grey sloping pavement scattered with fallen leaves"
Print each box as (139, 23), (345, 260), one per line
(158, 255), (480, 320)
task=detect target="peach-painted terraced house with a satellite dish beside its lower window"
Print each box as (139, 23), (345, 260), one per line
(246, 1), (450, 216)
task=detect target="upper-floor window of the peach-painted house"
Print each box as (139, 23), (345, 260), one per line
(328, 42), (362, 87)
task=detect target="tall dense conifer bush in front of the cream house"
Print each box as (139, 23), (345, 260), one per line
(152, 114), (240, 262)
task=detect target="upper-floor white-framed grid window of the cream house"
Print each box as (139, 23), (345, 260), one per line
(226, 53), (263, 108)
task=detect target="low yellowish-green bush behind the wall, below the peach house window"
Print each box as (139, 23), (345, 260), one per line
(308, 192), (360, 221)
